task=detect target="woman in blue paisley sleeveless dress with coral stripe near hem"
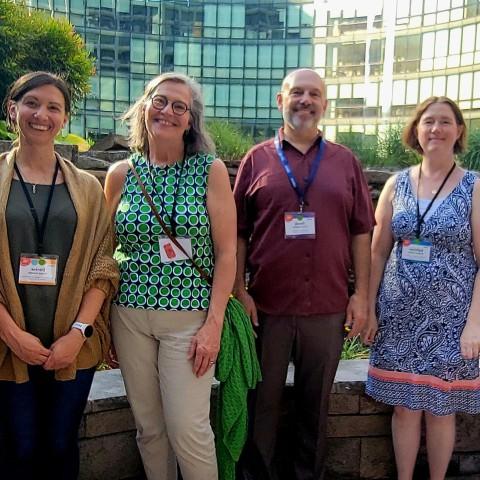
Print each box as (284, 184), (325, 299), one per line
(365, 97), (480, 480)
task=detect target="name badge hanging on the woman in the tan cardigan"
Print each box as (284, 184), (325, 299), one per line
(18, 253), (58, 285)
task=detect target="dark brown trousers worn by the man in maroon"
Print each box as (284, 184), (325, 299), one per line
(240, 313), (345, 480)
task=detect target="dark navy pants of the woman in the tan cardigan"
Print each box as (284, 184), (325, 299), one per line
(0, 367), (95, 480)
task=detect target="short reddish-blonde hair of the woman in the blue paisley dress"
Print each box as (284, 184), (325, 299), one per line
(402, 97), (467, 154)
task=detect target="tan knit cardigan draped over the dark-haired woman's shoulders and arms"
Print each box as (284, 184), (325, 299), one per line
(0, 149), (118, 383)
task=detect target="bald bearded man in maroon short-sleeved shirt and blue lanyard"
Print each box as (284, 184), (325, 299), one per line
(234, 69), (374, 480)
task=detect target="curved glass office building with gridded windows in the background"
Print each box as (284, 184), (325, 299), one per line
(22, 0), (480, 138)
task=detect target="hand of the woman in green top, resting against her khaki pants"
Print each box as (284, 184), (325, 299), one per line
(188, 320), (222, 377)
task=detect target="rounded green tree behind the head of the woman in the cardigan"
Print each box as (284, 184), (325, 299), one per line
(0, 0), (94, 118)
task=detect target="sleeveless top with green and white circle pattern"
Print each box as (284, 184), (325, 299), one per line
(114, 154), (214, 310)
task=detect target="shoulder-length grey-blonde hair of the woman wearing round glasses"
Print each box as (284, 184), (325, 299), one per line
(122, 72), (215, 156)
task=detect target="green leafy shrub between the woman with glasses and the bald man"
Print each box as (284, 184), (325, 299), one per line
(207, 120), (255, 160)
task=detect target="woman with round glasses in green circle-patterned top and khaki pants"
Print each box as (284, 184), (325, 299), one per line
(105, 73), (236, 480)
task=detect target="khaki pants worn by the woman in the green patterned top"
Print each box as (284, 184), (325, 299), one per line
(111, 305), (218, 480)
